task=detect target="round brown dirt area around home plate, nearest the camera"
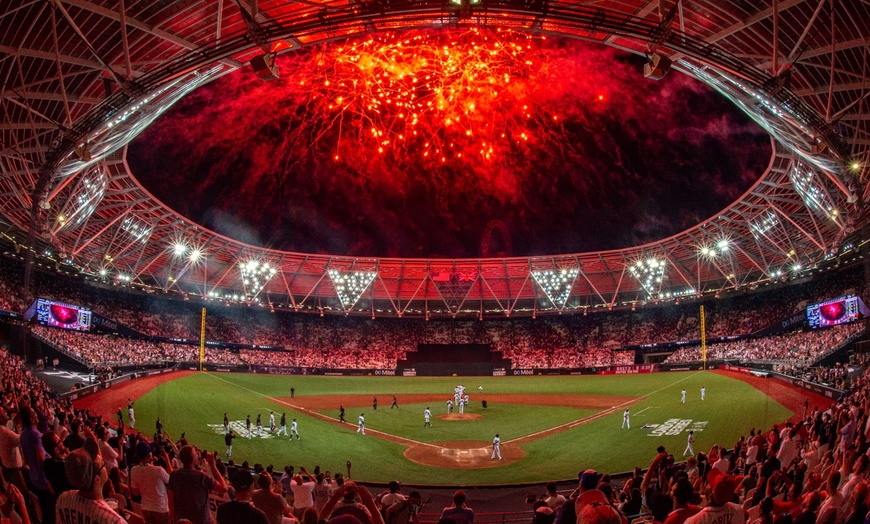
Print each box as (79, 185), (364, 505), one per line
(405, 440), (526, 469)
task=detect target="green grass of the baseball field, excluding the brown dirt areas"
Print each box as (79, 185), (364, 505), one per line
(136, 372), (792, 485)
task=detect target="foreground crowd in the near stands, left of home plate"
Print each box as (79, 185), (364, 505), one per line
(0, 349), (422, 524)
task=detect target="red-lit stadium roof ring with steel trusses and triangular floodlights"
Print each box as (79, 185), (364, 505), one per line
(0, 0), (870, 316)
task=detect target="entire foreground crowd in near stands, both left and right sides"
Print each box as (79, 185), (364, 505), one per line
(8, 328), (870, 524)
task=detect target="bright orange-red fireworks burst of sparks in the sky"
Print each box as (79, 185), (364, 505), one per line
(272, 28), (584, 172)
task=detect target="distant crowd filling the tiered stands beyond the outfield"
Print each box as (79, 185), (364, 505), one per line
(0, 254), (863, 369)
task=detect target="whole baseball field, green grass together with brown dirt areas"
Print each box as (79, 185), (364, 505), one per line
(78, 371), (829, 485)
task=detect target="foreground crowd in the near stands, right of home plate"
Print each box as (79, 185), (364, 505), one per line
(533, 354), (870, 524)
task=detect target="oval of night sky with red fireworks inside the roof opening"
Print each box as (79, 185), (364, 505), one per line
(128, 30), (771, 257)
